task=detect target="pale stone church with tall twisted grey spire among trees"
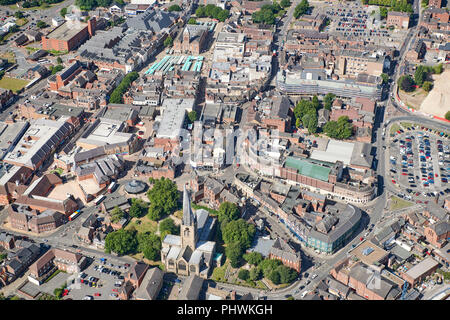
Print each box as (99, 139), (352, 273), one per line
(161, 186), (216, 279)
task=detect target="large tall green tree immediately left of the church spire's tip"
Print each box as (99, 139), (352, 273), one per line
(147, 177), (180, 220)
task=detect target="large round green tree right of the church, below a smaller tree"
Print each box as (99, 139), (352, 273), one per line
(221, 219), (255, 250)
